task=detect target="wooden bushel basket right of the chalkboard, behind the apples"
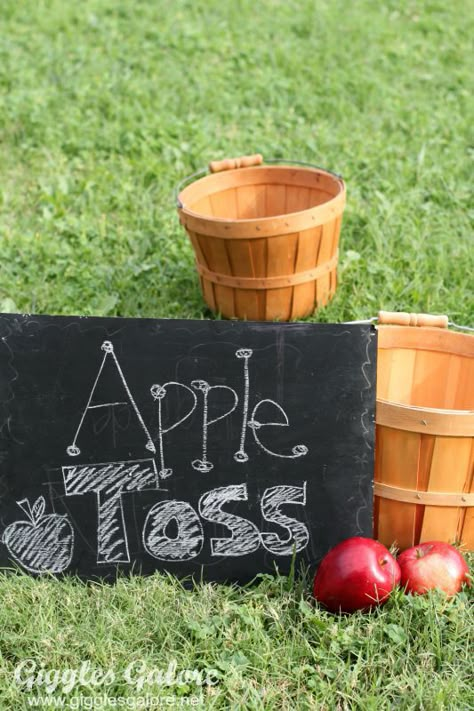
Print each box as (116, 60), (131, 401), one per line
(374, 312), (474, 550)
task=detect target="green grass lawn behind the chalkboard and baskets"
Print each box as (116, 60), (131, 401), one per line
(0, 0), (474, 325)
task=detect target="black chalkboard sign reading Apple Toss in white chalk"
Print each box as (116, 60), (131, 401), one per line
(0, 314), (376, 582)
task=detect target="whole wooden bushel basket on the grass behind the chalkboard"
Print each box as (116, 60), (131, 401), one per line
(177, 155), (346, 321)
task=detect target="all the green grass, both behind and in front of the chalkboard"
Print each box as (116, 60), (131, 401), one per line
(0, 0), (474, 711)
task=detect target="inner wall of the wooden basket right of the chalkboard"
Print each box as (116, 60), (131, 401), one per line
(377, 346), (474, 410)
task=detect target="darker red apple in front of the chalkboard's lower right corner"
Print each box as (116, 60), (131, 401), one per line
(313, 536), (400, 612)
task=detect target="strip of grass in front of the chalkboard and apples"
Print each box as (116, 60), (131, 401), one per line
(0, 572), (474, 711)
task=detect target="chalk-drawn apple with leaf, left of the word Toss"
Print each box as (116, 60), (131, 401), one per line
(2, 496), (74, 573)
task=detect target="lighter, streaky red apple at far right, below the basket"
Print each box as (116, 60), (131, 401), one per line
(398, 541), (469, 595)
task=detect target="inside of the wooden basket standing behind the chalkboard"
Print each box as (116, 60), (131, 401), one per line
(180, 167), (343, 220)
